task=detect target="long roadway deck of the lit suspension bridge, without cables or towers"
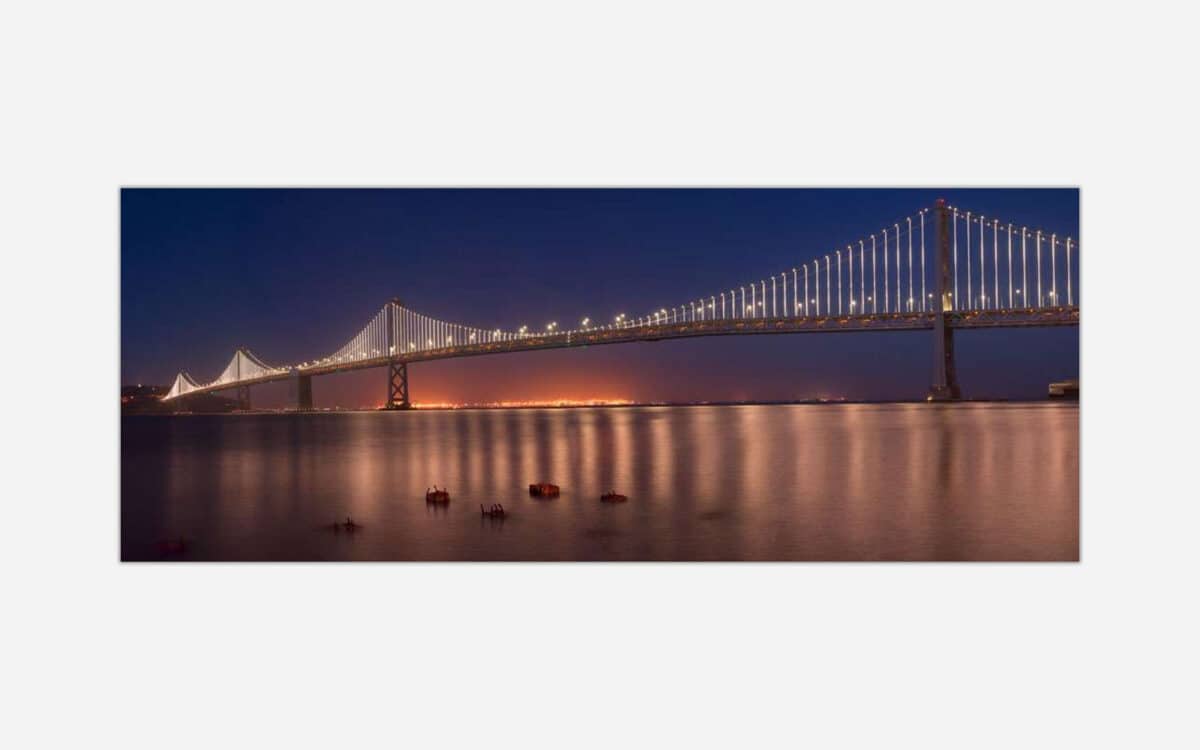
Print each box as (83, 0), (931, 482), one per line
(175, 305), (1079, 395)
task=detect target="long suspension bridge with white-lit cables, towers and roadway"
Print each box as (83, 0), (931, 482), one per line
(163, 200), (1079, 410)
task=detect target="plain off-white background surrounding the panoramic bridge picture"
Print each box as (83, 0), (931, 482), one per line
(0, 0), (1200, 749)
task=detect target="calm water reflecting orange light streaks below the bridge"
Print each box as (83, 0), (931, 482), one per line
(121, 403), (1079, 560)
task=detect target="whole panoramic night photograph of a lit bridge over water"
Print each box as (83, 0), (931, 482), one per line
(120, 186), (1081, 563)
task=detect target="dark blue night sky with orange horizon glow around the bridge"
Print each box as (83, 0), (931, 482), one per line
(121, 188), (1079, 407)
